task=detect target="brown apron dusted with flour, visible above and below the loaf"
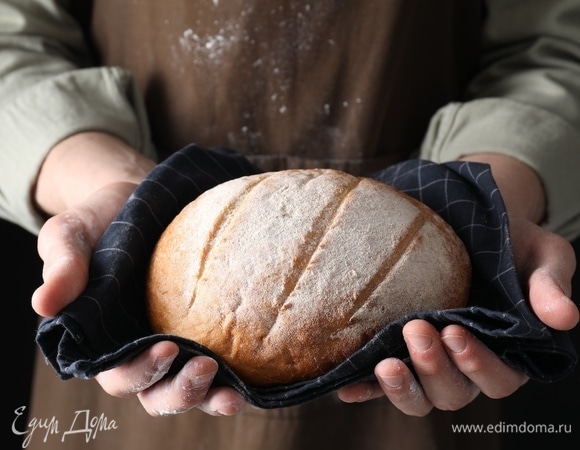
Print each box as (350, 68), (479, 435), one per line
(28, 0), (498, 450)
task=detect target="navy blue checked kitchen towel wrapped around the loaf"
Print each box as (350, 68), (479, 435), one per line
(37, 144), (577, 408)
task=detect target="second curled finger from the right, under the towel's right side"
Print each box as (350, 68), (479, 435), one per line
(398, 320), (479, 411)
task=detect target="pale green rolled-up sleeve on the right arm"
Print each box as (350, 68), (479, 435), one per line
(421, 0), (580, 243)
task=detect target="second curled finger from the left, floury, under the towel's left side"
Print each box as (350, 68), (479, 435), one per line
(137, 356), (223, 416)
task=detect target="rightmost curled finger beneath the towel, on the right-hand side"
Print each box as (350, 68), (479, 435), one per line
(441, 325), (528, 399)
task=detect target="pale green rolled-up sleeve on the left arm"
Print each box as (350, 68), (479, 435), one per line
(0, 0), (155, 233)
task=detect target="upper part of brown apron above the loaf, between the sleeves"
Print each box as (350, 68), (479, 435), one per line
(92, 0), (481, 174)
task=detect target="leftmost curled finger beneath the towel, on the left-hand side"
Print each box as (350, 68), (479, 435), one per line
(95, 341), (179, 397)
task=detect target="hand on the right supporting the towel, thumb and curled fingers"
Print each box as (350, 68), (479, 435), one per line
(338, 155), (579, 416)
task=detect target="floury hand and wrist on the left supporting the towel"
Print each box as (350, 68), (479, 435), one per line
(32, 134), (245, 415)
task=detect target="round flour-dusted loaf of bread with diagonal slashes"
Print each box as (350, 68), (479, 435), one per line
(147, 169), (471, 386)
